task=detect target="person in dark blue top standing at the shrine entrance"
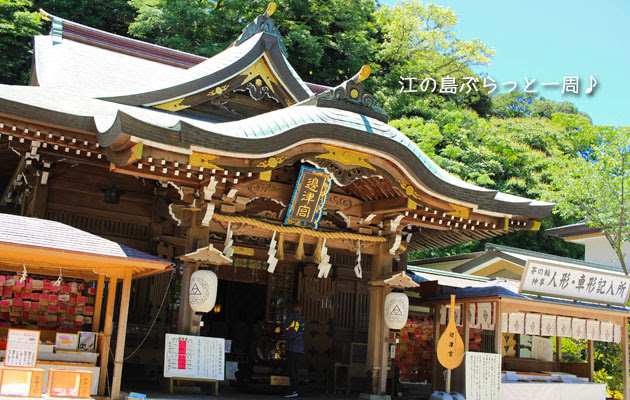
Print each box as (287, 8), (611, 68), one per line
(282, 301), (304, 398)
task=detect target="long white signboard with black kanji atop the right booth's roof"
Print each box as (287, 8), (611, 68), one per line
(519, 260), (630, 305)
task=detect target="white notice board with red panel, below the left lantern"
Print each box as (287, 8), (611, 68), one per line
(164, 333), (225, 381)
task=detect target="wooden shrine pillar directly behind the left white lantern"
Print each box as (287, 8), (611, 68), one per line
(177, 219), (210, 335)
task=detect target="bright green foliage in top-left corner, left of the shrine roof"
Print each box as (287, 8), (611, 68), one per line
(0, 0), (41, 84)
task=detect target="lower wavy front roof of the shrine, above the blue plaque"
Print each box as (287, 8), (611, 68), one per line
(0, 85), (553, 217)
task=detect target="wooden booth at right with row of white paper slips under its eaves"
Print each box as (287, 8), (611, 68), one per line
(408, 262), (629, 400)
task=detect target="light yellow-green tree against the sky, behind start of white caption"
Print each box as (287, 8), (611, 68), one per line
(375, 1), (494, 118)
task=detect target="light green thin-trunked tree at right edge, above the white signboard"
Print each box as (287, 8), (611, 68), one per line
(548, 127), (630, 275)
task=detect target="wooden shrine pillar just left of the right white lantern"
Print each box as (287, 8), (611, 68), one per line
(367, 245), (393, 394)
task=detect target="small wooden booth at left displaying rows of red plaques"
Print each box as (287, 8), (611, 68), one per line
(0, 214), (172, 399)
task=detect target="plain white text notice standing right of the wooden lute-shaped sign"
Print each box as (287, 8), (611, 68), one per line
(466, 351), (501, 400)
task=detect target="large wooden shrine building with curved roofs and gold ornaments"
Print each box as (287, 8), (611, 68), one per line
(0, 7), (553, 397)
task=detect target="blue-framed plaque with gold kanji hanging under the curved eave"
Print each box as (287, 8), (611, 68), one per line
(284, 167), (332, 229)
